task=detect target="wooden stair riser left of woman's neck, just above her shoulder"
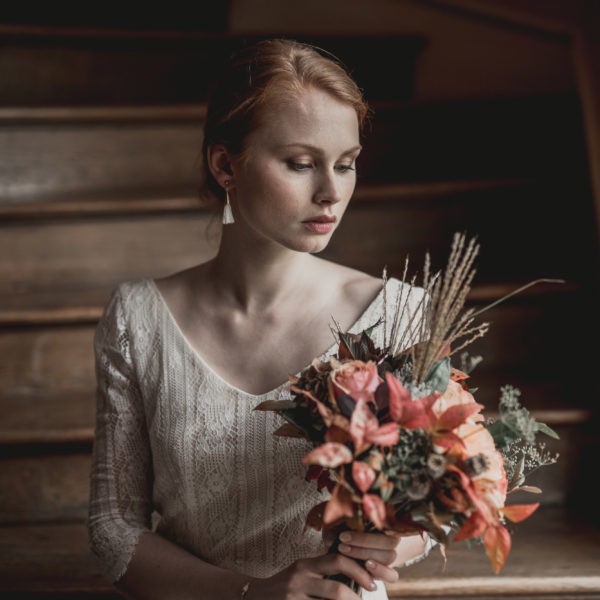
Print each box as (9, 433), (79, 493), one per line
(0, 215), (216, 310)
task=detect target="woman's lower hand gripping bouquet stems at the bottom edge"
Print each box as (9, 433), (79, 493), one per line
(246, 552), (376, 600)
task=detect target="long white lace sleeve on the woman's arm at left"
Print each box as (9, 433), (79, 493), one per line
(88, 287), (152, 583)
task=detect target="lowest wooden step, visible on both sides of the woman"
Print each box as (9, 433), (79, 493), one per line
(0, 507), (600, 600)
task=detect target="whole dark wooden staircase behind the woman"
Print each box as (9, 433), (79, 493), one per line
(0, 16), (600, 600)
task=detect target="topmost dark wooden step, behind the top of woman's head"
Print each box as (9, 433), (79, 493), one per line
(0, 24), (425, 106)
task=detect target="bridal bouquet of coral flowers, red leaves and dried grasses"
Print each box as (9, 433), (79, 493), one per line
(257, 235), (558, 589)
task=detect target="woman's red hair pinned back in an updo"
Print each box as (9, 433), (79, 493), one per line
(201, 39), (369, 206)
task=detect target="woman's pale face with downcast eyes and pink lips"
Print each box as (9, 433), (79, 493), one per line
(230, 88), (360, 252)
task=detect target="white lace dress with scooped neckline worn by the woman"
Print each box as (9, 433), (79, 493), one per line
(88, 278), (432, 599)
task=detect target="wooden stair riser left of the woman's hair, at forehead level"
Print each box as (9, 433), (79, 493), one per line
(0, 119), (202, 204)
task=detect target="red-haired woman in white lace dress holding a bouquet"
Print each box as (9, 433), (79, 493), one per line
(89, 40), (428, 600)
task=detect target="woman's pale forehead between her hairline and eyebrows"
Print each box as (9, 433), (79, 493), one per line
(249, 88), (359, 152)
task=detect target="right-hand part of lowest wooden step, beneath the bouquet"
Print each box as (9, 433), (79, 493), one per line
(389, 507), (600, 598)
